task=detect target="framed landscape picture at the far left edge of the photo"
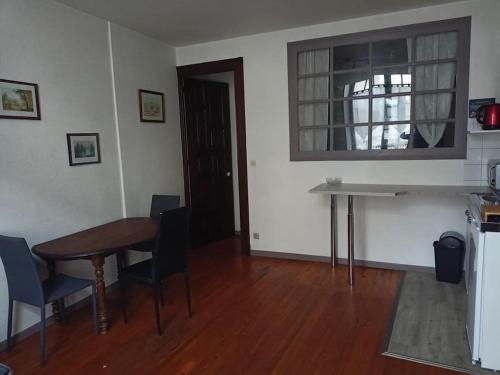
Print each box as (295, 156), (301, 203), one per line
(0, 79), (40, 120)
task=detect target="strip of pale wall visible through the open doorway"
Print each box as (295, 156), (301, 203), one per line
(195, 72), (241, 231)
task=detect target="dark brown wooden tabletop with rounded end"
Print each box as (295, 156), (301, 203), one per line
(32, 217), (157, 260)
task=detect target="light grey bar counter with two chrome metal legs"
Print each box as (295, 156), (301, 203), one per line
(309, 183), (492, 285)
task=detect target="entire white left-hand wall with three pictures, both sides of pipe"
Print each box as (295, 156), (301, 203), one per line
(0, 0), (183, 341)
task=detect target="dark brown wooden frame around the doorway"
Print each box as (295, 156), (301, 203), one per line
(177, 57), (250, 255)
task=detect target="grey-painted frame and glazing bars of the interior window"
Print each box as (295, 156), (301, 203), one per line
(287, 17), (471, 161)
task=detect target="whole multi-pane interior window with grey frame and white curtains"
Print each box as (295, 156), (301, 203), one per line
(288, 17), (470, 160)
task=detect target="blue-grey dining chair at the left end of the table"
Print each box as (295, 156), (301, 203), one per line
(0, 236), (97, 367)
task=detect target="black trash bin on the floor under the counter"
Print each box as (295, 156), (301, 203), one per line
(434, 232), (465, 284)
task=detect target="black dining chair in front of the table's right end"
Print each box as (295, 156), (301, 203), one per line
(118, 207), (192, 336)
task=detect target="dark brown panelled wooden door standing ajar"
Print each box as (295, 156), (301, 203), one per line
(184, 79), (234, 246)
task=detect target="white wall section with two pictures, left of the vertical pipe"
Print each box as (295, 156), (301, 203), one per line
(0, 0), (121, 339)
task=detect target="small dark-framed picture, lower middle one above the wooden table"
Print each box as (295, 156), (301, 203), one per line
(66, 133), (101, 166)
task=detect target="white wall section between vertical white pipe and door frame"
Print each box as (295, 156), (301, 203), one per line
(111, 25), (184, 217)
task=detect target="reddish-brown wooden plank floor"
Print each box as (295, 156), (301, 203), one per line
(0, 238), (456, 375)
